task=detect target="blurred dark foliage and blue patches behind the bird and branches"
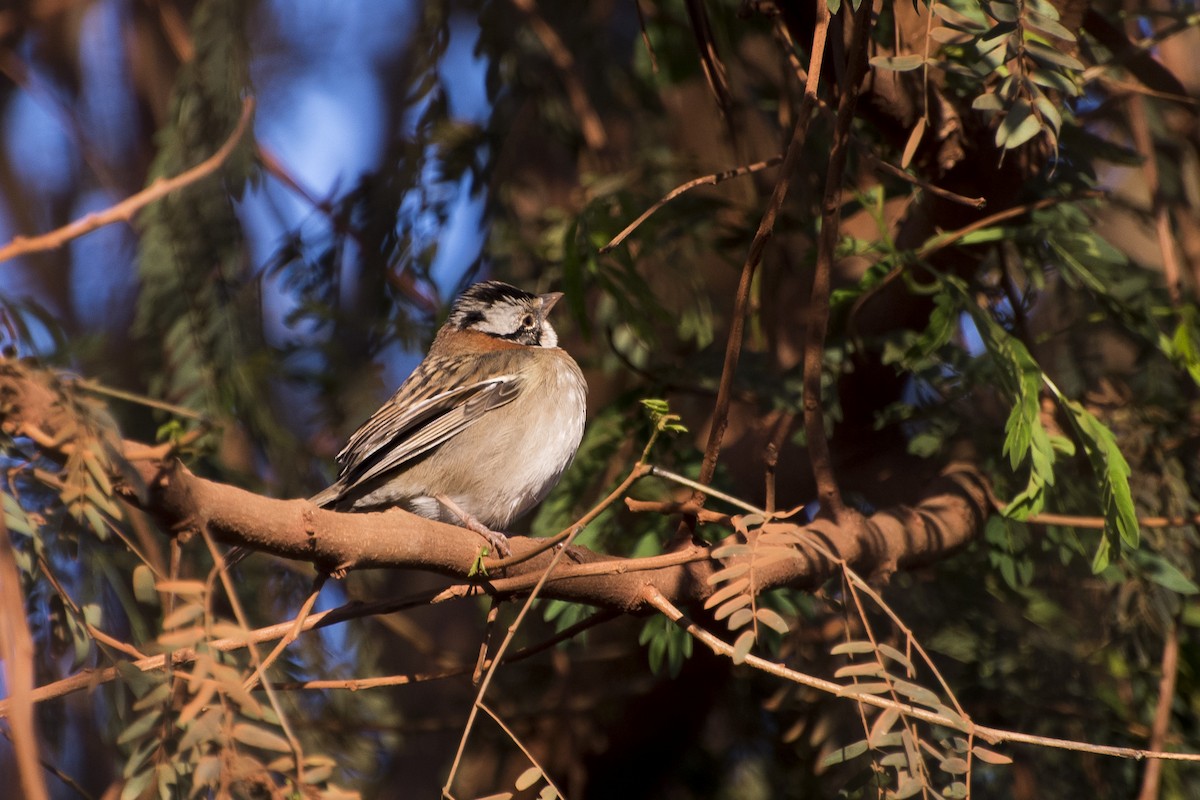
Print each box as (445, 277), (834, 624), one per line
(0, 0), (1200, 800)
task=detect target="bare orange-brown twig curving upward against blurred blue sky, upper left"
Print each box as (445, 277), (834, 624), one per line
(0, 97), (254, 261)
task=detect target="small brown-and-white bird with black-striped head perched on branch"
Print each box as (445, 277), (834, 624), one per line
(311, 281), (587, 558)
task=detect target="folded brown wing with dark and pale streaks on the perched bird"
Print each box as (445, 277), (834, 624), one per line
(337, 374), (521, 493)
